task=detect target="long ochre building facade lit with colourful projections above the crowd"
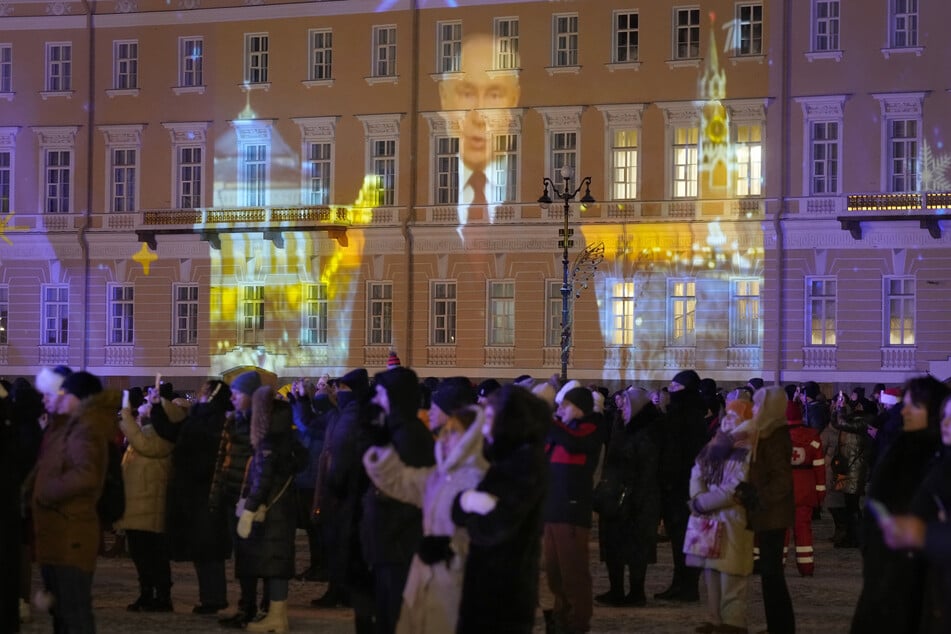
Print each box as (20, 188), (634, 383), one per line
(0, 0), (949, 385)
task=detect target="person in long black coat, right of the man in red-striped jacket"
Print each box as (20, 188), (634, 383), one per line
(595, 387), (663, 606)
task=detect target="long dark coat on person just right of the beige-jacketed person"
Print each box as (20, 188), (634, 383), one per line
(166, 403), (231, 561)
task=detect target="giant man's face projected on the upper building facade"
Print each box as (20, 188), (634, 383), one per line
(439, 35), (519, 171)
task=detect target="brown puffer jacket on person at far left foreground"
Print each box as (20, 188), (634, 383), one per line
(32, 390), (121, 573)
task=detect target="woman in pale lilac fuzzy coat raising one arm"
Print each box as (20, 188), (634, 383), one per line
(363, 405), (488, 634)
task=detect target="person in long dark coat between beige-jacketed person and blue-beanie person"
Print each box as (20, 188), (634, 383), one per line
(162, 380), (233, 614)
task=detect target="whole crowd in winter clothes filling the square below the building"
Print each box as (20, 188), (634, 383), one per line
(0, 354), (951, 634)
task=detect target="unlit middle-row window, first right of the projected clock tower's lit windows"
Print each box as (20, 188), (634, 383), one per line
(797, 95), (847, 197)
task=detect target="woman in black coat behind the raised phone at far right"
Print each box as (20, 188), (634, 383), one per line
(850, 376), (948, 634)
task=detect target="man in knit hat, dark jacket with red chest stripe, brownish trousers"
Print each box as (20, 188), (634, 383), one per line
(542, 386), (603, 632)
